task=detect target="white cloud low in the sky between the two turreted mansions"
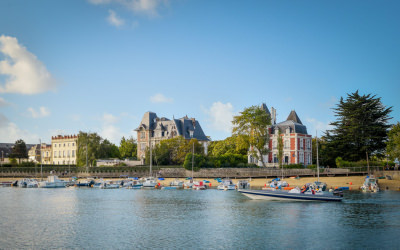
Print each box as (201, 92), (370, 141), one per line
(206, 102), (235, 133)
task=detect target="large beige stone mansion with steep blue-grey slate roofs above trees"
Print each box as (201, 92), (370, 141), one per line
(135, 112), (209, 160)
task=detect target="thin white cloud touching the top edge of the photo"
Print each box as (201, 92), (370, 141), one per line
(89, 0), (168, 17)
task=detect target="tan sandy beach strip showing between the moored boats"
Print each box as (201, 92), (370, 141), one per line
(0, 176), (400, 191)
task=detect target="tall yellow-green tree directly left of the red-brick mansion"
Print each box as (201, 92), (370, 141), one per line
(232, 106), (271, 167)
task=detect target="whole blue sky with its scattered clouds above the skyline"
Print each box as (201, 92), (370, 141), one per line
(0, 0), (400, 145)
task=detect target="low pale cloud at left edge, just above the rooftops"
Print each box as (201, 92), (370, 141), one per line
(0, 113), (39, 143)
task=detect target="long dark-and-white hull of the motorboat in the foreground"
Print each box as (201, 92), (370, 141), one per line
(238, 189), (342, 201)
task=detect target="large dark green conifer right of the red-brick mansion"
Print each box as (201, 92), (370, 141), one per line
(325, 90), (392, 161)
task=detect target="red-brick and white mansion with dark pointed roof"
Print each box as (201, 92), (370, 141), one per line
(248, 103), (312, 167)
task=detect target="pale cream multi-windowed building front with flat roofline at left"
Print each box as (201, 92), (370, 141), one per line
(51, 135), (78, 165)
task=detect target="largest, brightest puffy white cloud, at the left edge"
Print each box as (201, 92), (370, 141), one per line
(0, 35), (56, 95)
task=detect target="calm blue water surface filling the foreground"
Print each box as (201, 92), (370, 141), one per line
(0, 188), (400, 249)
